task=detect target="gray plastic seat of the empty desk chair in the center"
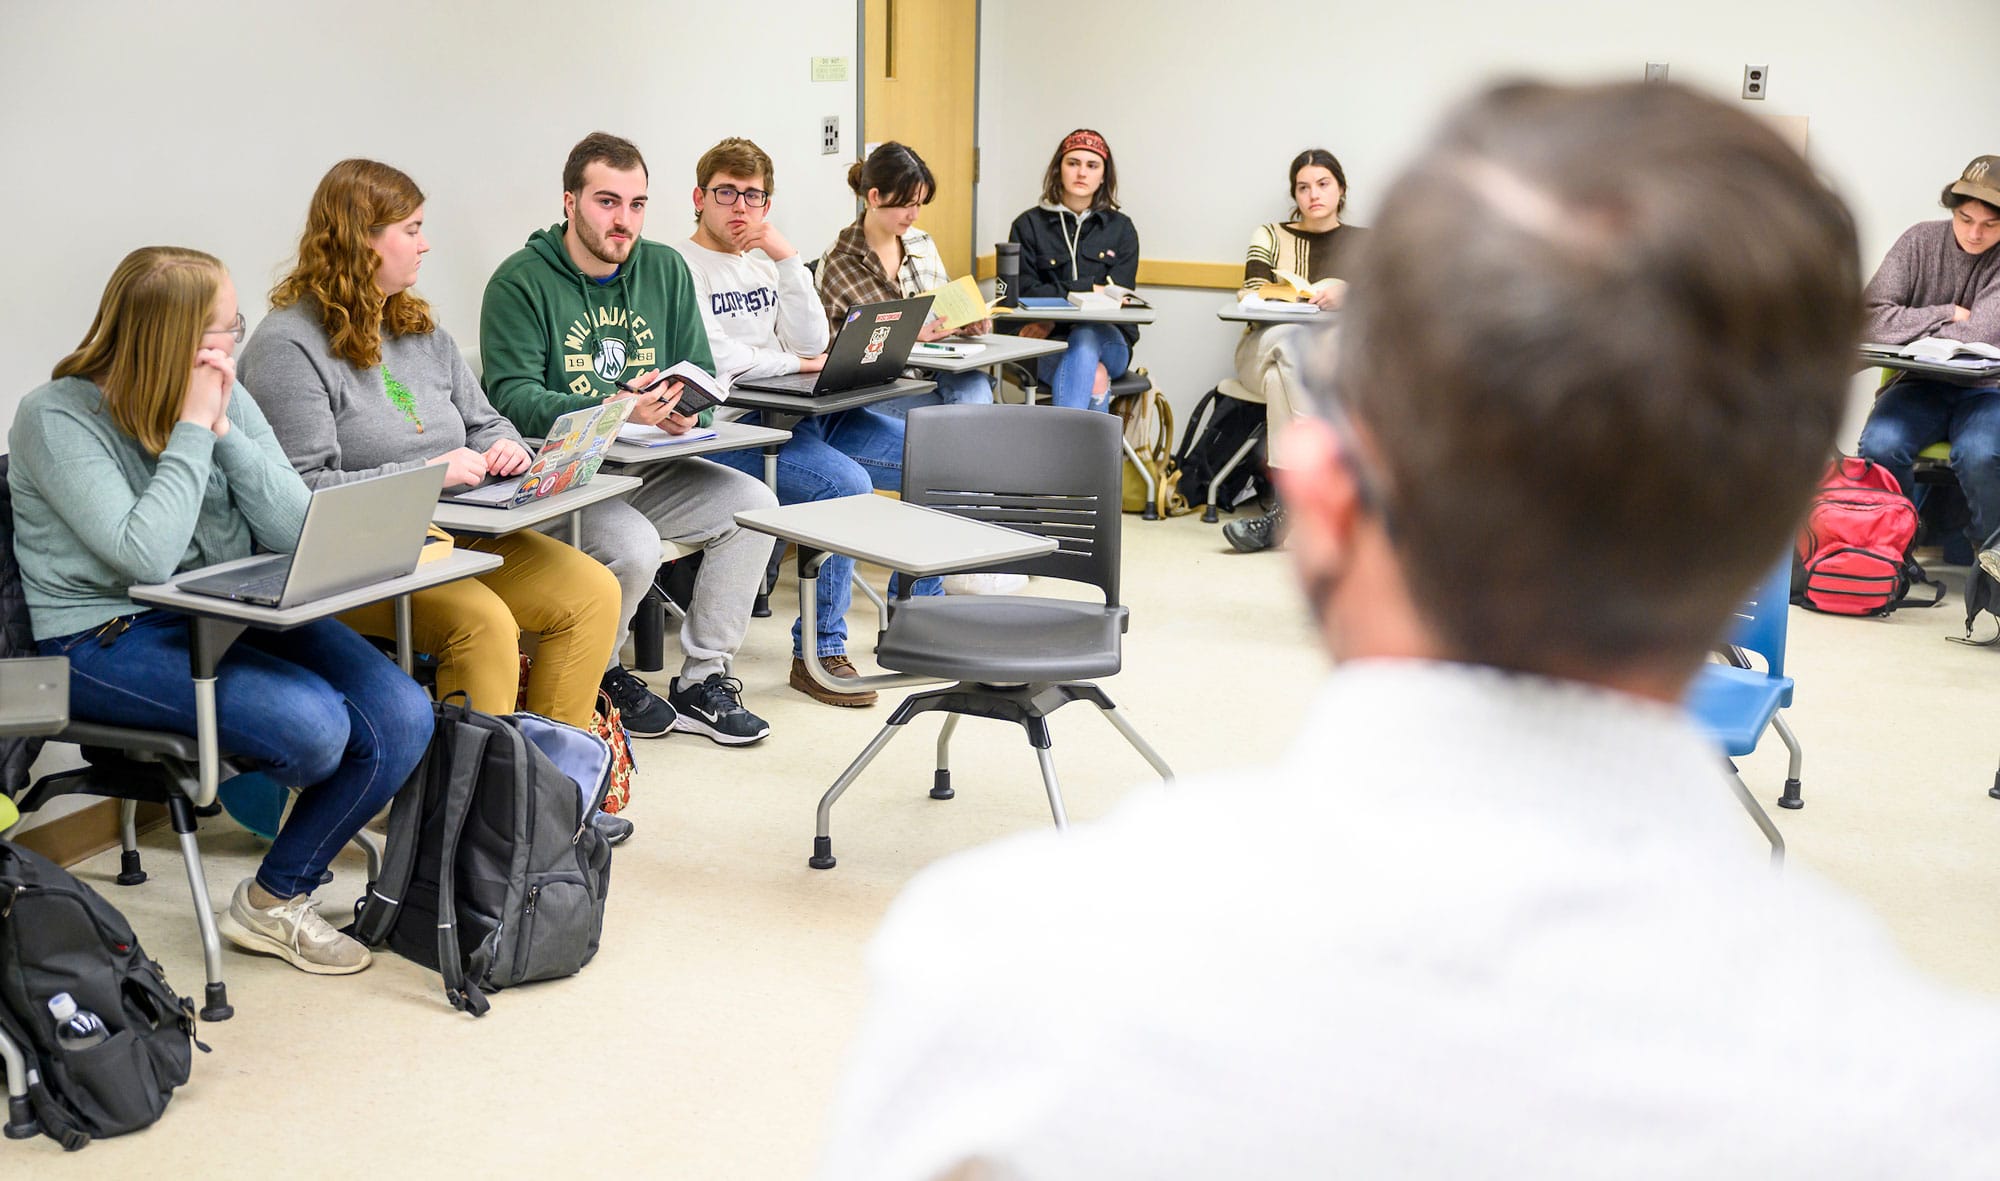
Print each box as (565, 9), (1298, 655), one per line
(876, 595), (1126, 683)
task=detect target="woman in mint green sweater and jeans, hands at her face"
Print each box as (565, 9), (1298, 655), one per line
(8, 246), (432, 975)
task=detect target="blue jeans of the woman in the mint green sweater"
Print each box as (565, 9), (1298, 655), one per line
(40, 611), (432, 899)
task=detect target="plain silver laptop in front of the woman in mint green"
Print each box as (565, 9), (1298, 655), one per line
(174, 464), (444, 607)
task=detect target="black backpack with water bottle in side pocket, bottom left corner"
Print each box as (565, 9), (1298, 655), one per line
(0, 841), (208, 1153)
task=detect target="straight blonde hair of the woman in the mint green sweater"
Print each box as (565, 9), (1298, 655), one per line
(50, 246), (228, 454)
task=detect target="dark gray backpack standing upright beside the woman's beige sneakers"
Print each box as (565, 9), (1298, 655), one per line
(350, 693), (612, 1017)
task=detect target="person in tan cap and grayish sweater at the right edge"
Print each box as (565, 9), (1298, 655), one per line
(1860, 156), (2000, 578)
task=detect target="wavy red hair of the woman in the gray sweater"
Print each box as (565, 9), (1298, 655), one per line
(270, 160), (438, 368)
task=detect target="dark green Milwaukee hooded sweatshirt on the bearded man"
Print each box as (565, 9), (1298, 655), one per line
(480, 222), (716, 436)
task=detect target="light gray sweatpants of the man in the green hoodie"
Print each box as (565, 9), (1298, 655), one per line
(556, 458), (778, 685)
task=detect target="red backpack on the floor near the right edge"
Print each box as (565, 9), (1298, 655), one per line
(1792, 456), (1944, 615)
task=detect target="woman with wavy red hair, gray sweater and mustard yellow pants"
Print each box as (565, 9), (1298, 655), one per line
(242, 160), (638, 748)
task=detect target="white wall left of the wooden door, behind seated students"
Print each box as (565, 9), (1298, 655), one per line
(0, 0), (856, 422)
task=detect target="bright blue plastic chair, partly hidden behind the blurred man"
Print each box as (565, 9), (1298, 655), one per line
(1688, 554), (1806, 865)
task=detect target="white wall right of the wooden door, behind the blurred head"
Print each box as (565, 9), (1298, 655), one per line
(976, 0), (2000, 426)
